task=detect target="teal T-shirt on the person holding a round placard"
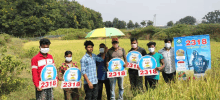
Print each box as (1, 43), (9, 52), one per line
(146, 52), (163, 80)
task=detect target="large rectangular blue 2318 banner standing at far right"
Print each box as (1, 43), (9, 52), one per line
(174, 35), (211, 76)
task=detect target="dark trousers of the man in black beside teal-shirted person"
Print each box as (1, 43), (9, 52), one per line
(128, 69), (143, 96)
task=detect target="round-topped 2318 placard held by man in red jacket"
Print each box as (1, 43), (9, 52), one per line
(40, 65), (57, 89)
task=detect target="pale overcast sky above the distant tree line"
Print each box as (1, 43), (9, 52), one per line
(76, 0), (220, 26)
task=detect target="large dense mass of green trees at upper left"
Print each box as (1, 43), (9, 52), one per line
(0, 0), (103, 36)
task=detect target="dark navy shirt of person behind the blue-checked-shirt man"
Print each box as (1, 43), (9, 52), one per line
(96, 54), (108, 80)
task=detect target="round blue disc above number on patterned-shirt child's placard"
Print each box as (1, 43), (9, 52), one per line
(63, 68), (81, 82)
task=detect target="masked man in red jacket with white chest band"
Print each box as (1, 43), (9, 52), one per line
(31, 38), (54, 100)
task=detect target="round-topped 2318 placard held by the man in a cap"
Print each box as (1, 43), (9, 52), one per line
(107, 58), (126, 78)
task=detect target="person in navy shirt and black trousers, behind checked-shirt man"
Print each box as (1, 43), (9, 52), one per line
(96, 43), (110, 100)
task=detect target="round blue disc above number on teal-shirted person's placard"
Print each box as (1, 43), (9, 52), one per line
(138, 55), (157, 70)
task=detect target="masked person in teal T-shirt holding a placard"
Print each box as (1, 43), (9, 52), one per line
(145, 42), (164, 90)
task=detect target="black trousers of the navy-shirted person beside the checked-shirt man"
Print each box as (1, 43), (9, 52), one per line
(98, 79), (110, 100)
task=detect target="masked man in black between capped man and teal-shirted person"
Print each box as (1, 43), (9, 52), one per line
(128, 38), (147, 96)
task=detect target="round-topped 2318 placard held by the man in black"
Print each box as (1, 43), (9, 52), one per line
(126, 51), (142, 69)
